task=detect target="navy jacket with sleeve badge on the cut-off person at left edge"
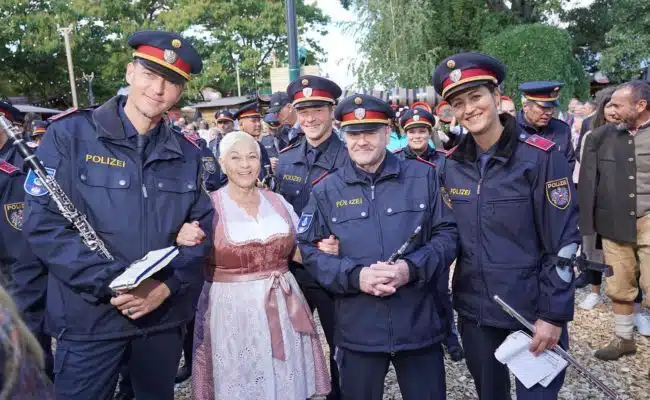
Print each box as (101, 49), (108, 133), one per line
(0, 163), (47, 334)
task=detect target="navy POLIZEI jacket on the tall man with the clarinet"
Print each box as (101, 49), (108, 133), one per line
(23, 96), (213, 340)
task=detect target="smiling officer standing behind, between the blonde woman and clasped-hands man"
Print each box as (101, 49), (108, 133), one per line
(272, 75), (348, 399)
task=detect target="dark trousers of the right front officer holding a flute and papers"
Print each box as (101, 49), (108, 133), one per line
(458, 317), (569, 400)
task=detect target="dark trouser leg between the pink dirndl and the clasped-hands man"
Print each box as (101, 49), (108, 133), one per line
(291, 262), (341, 400)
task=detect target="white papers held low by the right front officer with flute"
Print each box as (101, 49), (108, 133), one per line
(494, 331), (568, 389)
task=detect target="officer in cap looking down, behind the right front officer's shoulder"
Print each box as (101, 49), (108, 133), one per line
(517, 81), (576, 171)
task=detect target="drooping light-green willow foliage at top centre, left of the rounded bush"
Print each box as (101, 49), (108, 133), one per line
(347, 0), (515, 88)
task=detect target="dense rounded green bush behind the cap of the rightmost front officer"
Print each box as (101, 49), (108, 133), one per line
(481, 24), (589, 106)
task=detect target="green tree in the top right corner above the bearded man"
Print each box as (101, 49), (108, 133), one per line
(600, 0), (650, 81)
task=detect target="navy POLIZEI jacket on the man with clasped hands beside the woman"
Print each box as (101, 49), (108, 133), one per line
(298, 151), (458, 353)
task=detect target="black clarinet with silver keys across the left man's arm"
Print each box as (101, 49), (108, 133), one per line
(0, 115), (114, 260)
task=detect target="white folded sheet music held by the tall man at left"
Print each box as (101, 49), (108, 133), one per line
(110, 246), (179, 291)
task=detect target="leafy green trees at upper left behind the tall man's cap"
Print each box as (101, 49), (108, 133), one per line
(0, 0), (328, 105)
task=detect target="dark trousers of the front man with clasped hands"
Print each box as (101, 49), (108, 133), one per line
(336, 344), (447, 400)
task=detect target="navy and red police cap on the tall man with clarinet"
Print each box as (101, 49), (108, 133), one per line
(128, 31), (203, 84)
